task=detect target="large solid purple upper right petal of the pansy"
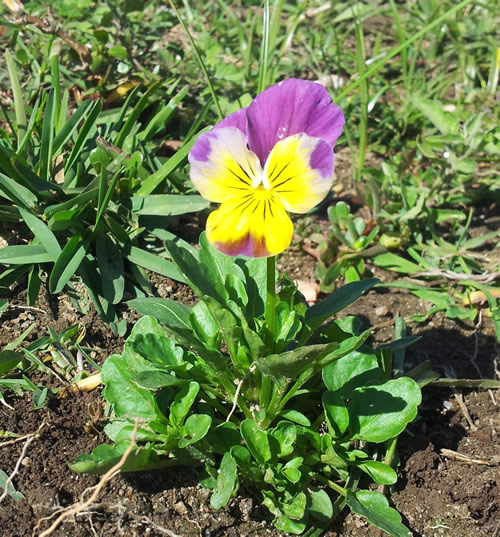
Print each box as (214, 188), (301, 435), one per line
(245, 78), (345, 165)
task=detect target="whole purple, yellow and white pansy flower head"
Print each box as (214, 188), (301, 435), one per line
(189, 78), (344, 257)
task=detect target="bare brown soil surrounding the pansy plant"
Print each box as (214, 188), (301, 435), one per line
(0, 215), (500, 537)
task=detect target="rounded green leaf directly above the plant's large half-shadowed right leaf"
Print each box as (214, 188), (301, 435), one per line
(322, 347), (381, 398)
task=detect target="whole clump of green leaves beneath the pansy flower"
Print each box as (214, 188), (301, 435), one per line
(70, 235), (421, 537)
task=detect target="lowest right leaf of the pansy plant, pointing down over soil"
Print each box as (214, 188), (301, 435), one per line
(346, 490), (411, 537)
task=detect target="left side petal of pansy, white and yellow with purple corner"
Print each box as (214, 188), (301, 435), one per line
(189, 127), (262, 203)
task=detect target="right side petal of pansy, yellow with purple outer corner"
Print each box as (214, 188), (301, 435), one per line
(264, 134), (333, 213)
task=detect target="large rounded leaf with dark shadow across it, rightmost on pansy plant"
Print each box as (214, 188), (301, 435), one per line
(348, 377), (422, 442)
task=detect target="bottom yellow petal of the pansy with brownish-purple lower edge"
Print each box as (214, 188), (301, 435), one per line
(207, 187), (293, 257)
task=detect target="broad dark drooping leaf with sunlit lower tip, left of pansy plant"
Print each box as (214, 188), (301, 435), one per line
(96, 234), (125, 304)
